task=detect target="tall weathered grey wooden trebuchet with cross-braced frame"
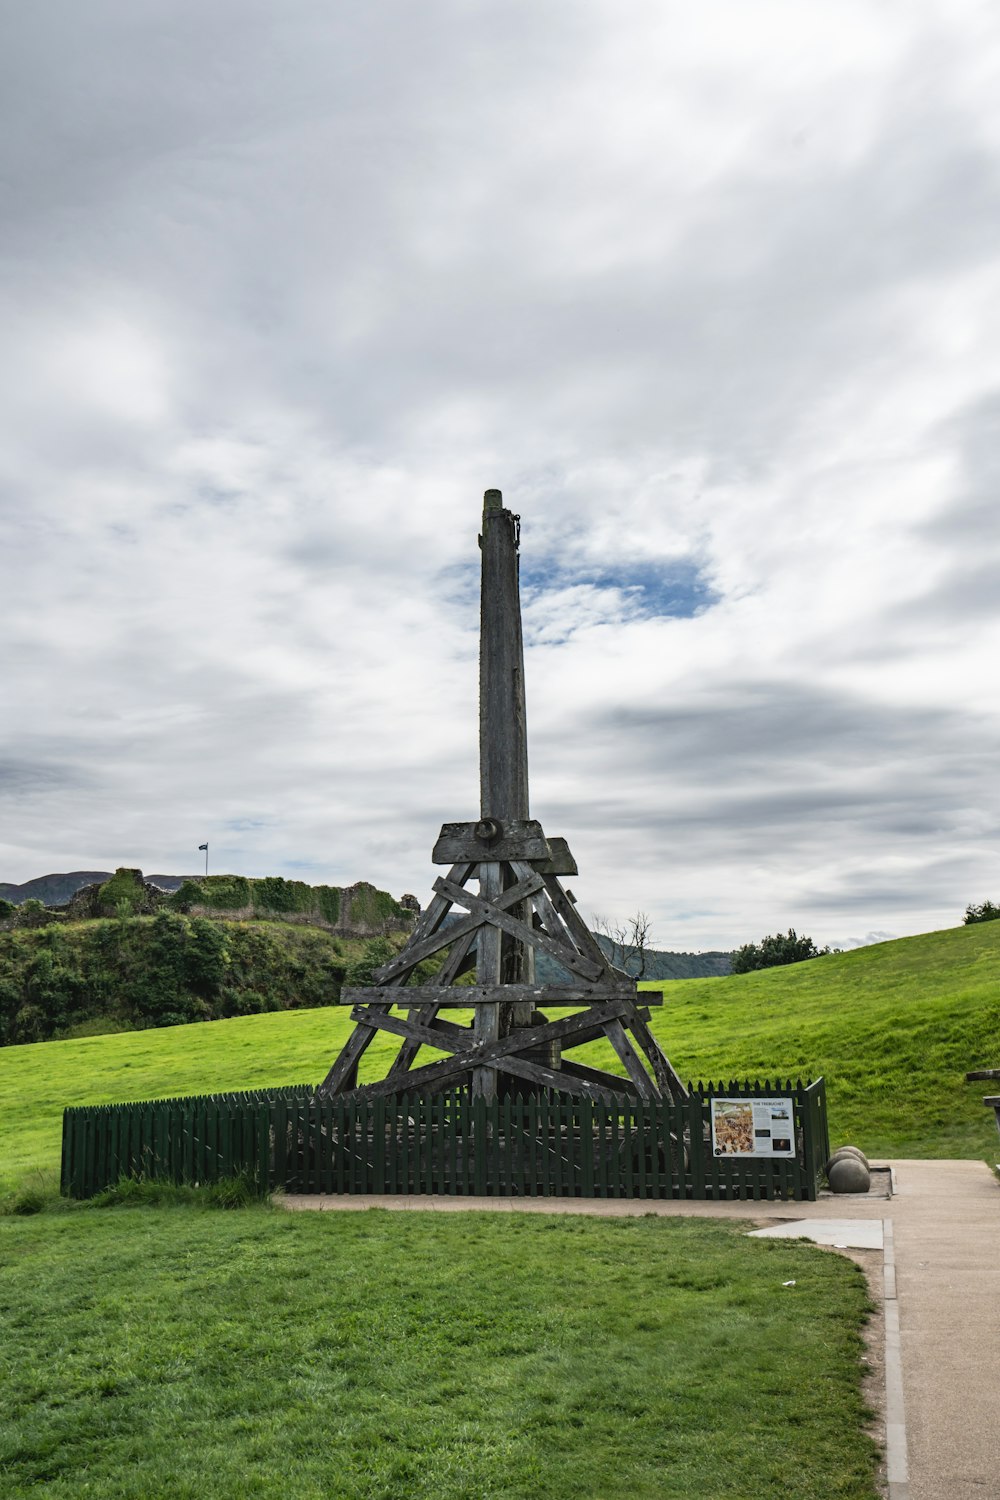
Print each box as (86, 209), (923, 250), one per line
(318, 489), (687, 1103)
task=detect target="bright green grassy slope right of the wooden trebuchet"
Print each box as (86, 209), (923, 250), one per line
(641, 921), (1000, 1163)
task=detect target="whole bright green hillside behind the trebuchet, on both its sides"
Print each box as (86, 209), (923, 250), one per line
(0, 923), (1000, 1194)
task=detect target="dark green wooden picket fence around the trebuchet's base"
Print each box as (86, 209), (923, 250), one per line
(61, 1079), (829, 1200)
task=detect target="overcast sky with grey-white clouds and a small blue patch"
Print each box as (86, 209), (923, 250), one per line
(0, 0), (1000, 950)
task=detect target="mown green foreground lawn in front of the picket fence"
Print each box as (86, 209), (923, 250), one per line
(0, 1208), (876, 1500)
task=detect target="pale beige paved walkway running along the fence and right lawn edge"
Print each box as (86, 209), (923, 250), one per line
(286, 1161), (1000, 1500)
